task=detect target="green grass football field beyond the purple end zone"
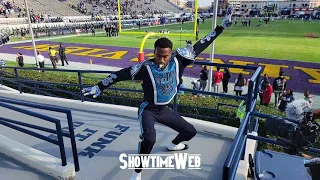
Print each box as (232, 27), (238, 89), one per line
(48, 19), (320, 62)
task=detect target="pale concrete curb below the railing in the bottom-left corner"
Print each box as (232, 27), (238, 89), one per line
(0, 135), (76, 179)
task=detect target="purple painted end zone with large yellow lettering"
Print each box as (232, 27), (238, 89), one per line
(0, 41), (320, 95)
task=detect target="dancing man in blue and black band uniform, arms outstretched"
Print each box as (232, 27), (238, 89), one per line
(83, 7), (232, 180)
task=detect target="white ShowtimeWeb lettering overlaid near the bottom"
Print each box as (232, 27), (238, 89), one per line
(119, 153), (201, 169)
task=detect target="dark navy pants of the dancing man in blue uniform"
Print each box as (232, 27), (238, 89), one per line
(135, 103), (197, 173)
